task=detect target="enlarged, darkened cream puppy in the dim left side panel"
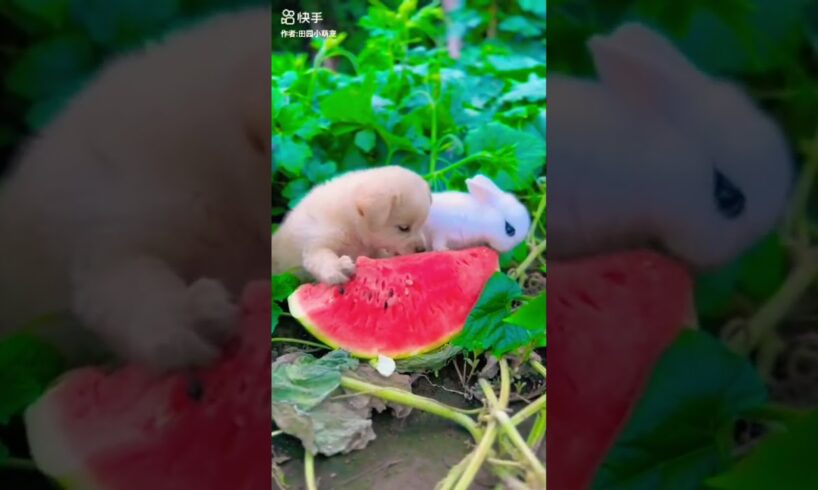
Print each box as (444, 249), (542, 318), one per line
(0, 9), (271, 370)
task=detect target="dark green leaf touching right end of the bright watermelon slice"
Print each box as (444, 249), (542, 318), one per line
(452, 272), (543, 356)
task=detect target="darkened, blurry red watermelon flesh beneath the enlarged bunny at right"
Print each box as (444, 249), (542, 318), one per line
(547, 251), (694, 490)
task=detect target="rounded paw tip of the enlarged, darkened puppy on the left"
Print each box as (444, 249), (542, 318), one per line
(187, 278), (239, 344)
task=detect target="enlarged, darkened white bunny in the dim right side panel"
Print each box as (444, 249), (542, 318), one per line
(548, 23), (793, 268)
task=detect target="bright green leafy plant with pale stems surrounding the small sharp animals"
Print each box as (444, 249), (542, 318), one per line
(271, 0), (546, 488)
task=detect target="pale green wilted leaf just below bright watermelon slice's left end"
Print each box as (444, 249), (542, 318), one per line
(270, 350), (358, 411)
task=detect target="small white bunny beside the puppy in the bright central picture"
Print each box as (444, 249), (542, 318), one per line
(423, 175), (531, 252)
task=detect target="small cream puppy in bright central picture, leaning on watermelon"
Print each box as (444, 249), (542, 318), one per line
(272, 166), (432, 284)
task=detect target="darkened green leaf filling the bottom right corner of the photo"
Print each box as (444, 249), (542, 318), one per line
(707, 410), (818, 490)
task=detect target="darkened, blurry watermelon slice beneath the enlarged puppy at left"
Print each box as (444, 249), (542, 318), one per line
(25, 283), (271, 490)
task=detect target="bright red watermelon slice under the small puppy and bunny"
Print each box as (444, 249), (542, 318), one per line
(288, 247), (499, 359)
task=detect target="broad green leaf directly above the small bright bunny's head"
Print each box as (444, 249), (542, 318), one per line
(465, 122), (545, 191)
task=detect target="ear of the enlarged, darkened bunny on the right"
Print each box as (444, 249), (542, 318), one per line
(588, 23), (709, 115)
